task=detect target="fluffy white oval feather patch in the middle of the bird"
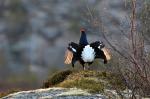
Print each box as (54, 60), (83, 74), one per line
(81, 45), (95, 62)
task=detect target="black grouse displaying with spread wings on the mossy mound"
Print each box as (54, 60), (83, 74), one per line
(65, 28), (110, 69)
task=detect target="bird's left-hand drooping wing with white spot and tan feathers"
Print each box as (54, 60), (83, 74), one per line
(64, 42), (79, 64)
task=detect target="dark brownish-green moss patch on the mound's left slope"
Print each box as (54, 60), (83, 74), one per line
(43, 70), (72, 88)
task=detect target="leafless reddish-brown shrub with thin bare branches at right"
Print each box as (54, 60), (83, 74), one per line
(84, 0), (150, 99)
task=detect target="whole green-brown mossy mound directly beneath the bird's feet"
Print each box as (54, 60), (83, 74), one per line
(44, 70), (126, 93)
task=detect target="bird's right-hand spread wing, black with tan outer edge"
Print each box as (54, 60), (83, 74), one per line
(90, 41), (111, 64)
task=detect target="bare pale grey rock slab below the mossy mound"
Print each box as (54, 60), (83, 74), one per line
(2, 88), (107, 99)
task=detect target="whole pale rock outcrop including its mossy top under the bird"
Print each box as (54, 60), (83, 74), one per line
(2, 70), (146, 99)
